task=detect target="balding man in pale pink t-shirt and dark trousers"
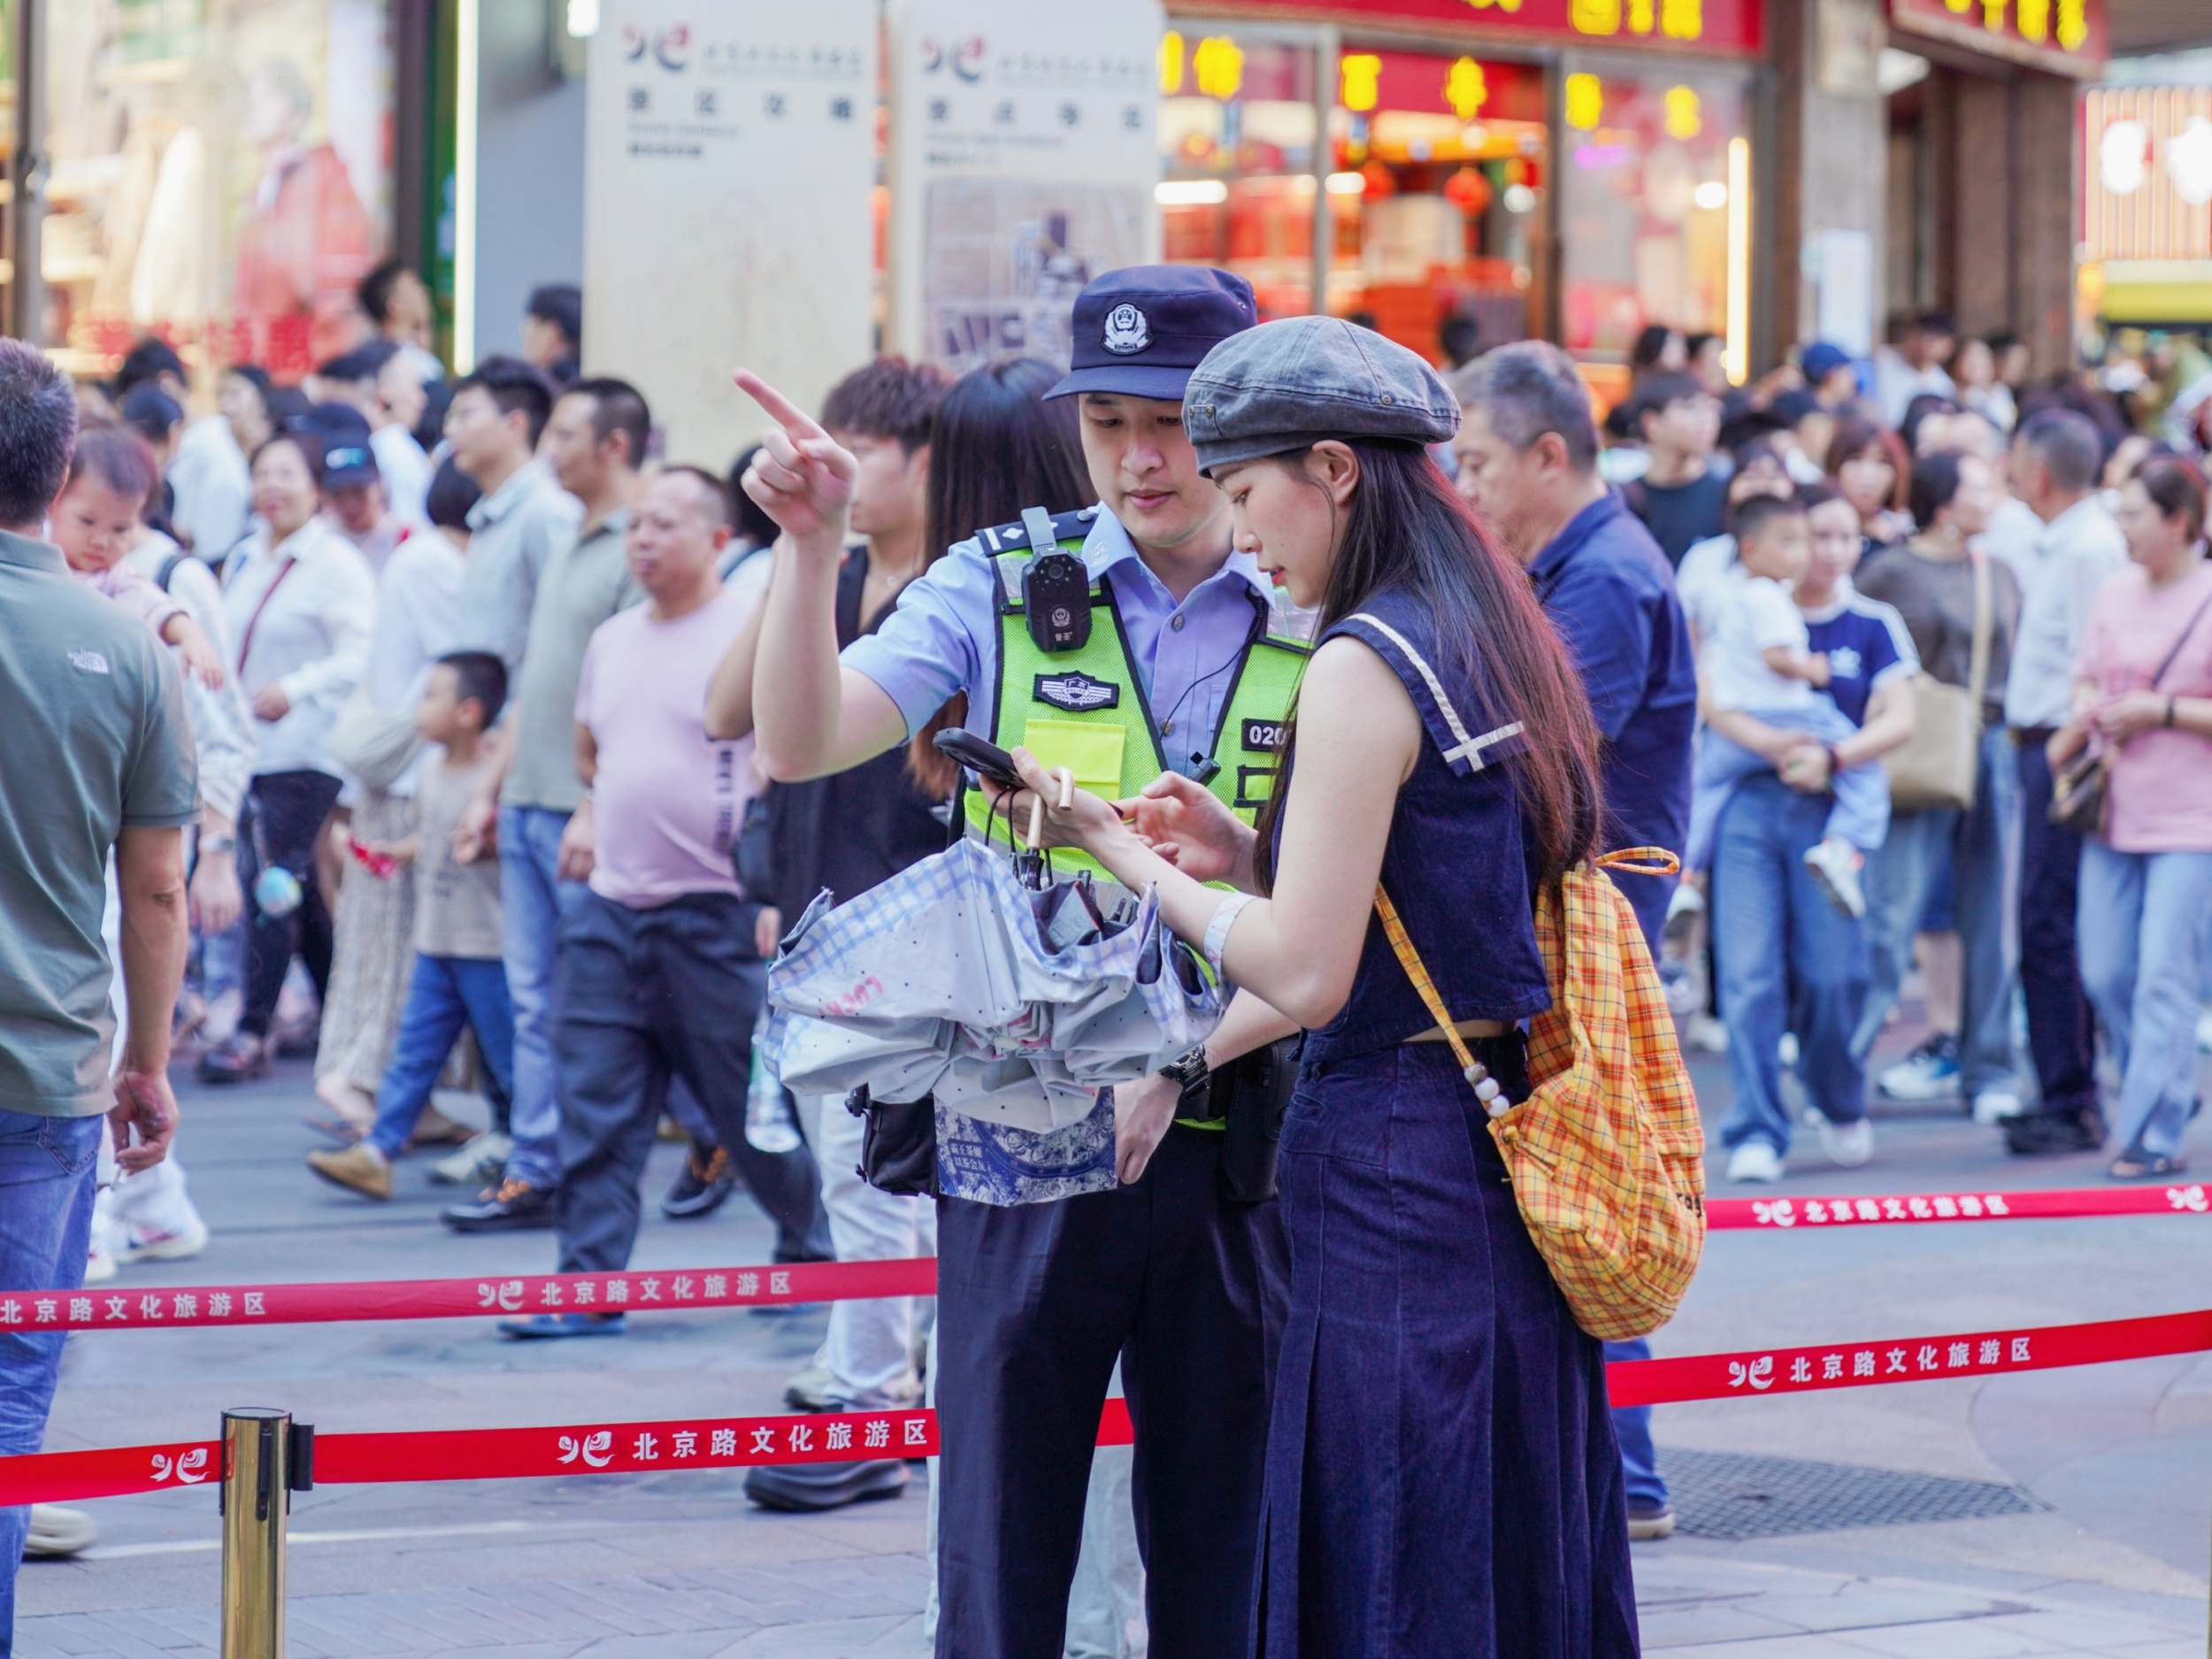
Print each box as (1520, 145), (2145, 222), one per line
(500, 467), (832, 1336)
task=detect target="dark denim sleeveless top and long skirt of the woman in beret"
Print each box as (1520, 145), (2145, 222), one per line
(1255, 595), (1637, 1659)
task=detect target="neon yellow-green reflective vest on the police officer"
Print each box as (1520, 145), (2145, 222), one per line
(960, 509), (1312, 880)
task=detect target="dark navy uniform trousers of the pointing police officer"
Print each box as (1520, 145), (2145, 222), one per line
(932, 1126), (1290, 1659)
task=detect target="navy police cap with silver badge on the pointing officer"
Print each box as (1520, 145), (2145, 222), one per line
(1044, 265), (1259, 401)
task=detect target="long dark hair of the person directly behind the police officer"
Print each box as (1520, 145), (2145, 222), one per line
(907, 357), (1097, 801)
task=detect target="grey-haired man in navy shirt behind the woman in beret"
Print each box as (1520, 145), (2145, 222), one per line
(1454, 341), (1697, 1538)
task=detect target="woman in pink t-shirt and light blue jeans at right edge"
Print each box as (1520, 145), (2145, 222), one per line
(2051, 458), (2212, 1181)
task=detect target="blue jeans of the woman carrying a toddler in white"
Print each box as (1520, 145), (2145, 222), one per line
(1712, 774), (1867, 1153)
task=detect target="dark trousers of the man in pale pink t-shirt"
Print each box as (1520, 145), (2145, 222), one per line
(553, 894), (836, 1274)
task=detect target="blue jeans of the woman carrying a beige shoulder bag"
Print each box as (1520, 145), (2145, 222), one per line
(1852, 726), (2020, 1100)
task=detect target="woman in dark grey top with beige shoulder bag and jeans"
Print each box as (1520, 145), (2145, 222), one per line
(1852, 451), (2022, 1122)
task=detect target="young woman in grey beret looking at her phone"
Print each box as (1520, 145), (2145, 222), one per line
(1011, 317), (1637, 1659)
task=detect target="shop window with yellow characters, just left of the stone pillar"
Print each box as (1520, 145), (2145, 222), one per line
(1560, 66), (1750, 389)
